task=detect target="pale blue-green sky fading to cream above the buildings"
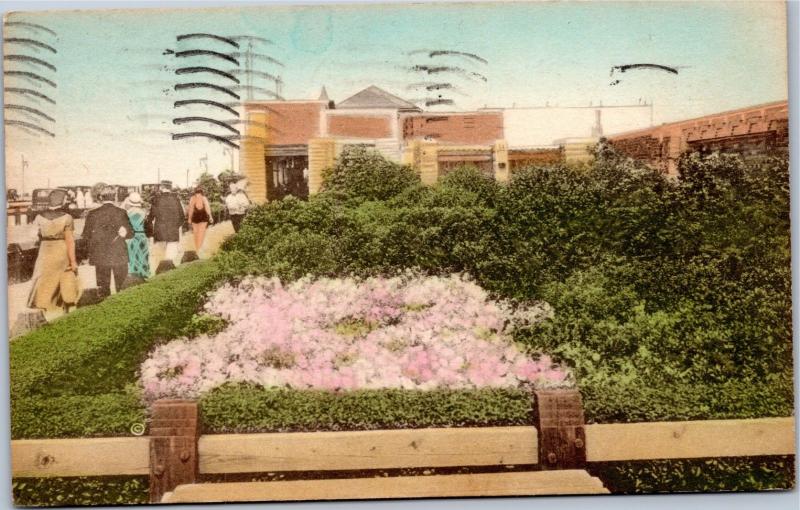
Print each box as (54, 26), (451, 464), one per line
(4, 2), (787, 190)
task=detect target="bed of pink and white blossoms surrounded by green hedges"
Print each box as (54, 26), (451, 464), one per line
(141, 274), (572, 399)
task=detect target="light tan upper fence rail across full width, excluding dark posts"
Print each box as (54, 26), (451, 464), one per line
(11, 417), (795, 478)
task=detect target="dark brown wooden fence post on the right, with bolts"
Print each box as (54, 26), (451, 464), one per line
(534, 390), (586, 470)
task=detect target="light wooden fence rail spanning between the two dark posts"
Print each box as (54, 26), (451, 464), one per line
(199, 427), (538, 473)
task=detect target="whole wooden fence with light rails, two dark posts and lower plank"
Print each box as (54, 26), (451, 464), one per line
(11, 392), (795, 502)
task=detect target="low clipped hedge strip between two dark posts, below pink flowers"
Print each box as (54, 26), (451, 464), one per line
(200, 385), (533, 433)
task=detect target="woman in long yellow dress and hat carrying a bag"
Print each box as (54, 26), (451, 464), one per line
(28, 189), (78, 319)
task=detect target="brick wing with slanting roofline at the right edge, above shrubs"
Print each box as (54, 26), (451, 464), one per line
(608, 101), (789, 175)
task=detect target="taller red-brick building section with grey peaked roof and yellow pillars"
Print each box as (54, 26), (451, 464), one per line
(240, 86), (508, 202)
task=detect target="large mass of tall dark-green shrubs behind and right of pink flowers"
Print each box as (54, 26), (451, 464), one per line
(220, 145), (792, 420)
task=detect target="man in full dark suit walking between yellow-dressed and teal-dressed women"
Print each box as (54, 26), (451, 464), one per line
(81, 187), (133, 297)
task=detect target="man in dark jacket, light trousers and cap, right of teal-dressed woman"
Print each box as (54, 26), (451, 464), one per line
(145, 181), (186, 267)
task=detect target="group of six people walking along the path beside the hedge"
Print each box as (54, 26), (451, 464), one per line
(28, 177), (251, 317)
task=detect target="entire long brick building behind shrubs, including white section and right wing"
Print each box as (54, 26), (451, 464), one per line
(240, 86), (788, 203)
